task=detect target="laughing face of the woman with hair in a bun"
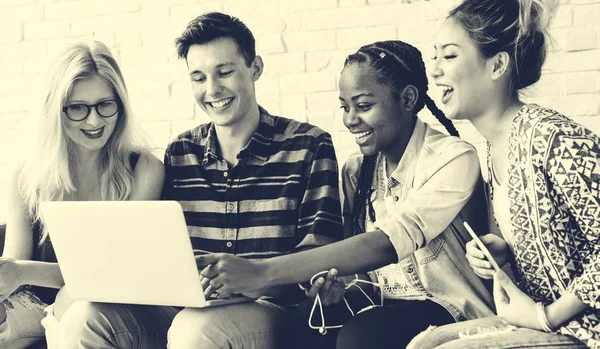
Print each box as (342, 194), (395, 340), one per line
(431, 18), (494, 119)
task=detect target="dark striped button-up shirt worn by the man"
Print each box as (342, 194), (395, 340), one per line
(163, 108), (343, 258)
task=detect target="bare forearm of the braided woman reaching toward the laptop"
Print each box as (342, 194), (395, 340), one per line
(260, 230), (398, 285)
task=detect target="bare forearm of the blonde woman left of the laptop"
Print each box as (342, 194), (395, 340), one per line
(17, 260), (65, 288)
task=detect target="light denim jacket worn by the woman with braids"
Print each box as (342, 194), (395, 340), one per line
(342, 120), (494, 321)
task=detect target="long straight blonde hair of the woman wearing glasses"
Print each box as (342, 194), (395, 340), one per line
(17, 41), (146, 244)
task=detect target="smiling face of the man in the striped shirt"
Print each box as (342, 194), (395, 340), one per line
(186, 37), (262, 126)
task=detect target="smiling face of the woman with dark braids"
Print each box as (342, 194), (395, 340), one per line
(339, 63), (413, 155)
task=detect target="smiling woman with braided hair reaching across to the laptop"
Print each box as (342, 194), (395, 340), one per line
(199, 41), (492, 349)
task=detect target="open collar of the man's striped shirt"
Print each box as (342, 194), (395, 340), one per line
(202, 106), (276, 165)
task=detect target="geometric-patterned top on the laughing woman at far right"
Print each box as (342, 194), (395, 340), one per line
(508, 104), (600, 348)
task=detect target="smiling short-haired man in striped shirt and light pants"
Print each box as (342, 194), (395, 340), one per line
(163, 12), (343, 349)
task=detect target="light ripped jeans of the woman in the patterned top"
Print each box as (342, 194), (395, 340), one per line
(407, 316), (587, 349)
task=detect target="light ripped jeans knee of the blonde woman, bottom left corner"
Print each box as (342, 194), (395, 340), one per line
(0, 290), (46, 349)
